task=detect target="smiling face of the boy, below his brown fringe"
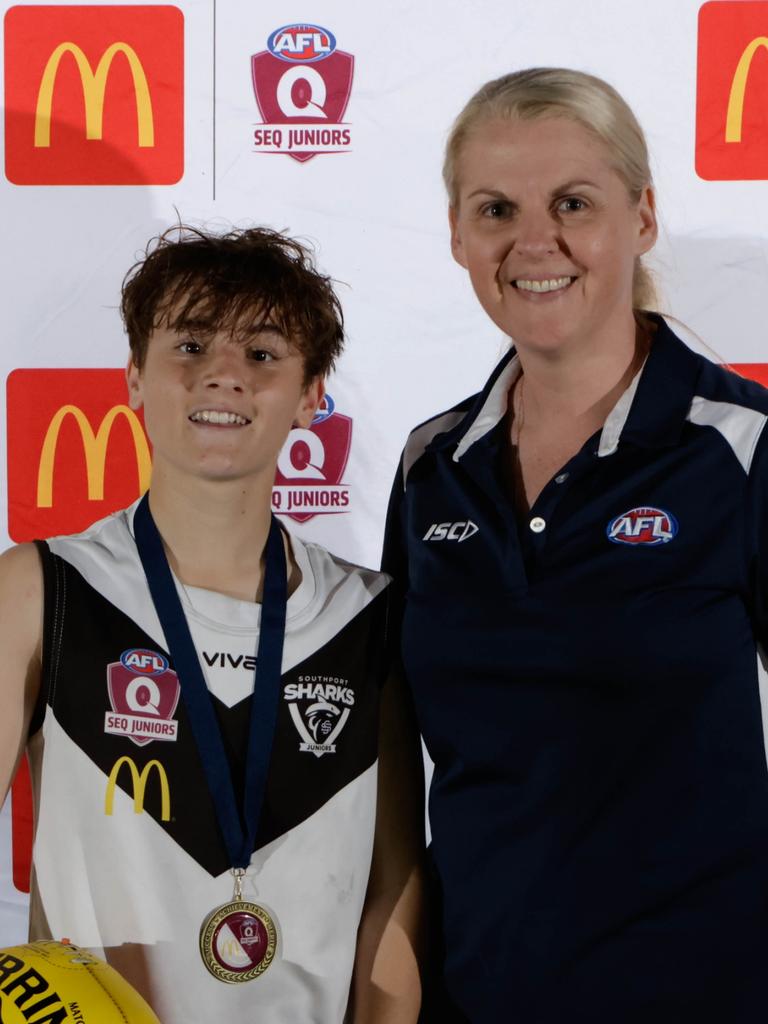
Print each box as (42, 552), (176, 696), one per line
(127, 313), (324, 485)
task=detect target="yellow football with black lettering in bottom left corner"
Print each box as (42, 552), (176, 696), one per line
(0, 941), (160, 1024)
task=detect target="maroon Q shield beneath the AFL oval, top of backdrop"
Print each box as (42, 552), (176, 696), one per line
(251, 50), (354, 162)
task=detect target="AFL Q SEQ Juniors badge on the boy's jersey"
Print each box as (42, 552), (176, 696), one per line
(104, 647), (181, 746)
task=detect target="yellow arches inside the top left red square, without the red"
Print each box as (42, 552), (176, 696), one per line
(35, 42), (155, 148)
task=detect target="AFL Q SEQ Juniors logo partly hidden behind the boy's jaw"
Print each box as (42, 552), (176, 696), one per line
(272, 394), (352, 522)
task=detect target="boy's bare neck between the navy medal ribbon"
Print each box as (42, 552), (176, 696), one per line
(144, 474), (301, 601)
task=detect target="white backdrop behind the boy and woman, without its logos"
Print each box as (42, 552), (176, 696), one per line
(0, 0), (768, 946)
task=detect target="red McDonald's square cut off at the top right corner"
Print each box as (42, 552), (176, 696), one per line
(696, 0), (768, 181)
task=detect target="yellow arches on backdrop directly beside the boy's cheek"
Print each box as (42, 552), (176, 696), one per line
(37, 406), (152, 509)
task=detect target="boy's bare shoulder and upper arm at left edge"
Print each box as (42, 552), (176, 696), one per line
(0, 544), (43, 807)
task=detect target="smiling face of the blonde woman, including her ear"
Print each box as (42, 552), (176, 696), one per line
(450, 118), (656, 354)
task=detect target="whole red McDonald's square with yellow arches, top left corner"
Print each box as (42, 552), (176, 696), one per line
(5, 5), (184, 185)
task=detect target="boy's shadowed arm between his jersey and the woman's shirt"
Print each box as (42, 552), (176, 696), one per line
(348, 673), (424, 1024)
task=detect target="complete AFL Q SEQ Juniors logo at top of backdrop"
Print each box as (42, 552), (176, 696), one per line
(251, 24), (354, 163)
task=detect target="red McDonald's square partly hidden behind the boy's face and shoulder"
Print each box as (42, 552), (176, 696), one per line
(6, 370), (152, 542)
